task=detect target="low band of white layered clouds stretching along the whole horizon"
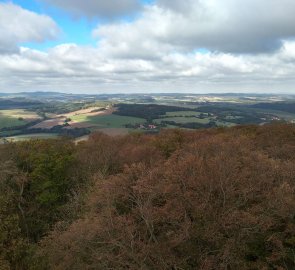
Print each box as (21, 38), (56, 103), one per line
(0, 41), (295, 93)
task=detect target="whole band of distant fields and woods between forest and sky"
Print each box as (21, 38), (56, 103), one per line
(0, 93), (295, 140)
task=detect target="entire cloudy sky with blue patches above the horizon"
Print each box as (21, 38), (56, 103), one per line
(0, 0), (295, 94)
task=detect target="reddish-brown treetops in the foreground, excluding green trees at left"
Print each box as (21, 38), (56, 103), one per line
(25, 125), (295, 270)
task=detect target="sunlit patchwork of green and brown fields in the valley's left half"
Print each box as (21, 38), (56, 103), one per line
(0, 106), (146, 140)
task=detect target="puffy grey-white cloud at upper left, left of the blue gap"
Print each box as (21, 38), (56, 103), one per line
(0, 3), (59, 53)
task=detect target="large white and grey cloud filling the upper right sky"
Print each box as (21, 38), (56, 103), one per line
(93, 0), (295, 57)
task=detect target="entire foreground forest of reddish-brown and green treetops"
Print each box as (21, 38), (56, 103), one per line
(0, 123), (295, 270)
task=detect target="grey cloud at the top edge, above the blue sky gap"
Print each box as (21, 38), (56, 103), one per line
(40, 0), (140, 18)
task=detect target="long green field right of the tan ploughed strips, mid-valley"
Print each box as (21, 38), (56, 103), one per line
(71, 114), (145, 128)
